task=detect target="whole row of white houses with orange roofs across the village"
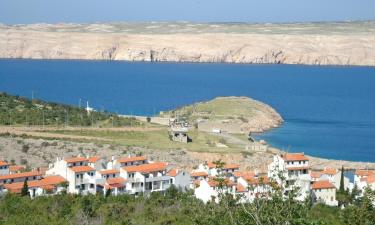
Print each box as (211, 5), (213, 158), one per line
(0, 153), (375, 206)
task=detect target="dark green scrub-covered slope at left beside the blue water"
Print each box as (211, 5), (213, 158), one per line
(0, 93), (140, 127)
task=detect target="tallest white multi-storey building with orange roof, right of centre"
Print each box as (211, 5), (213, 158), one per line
(268, 153), (311, 201)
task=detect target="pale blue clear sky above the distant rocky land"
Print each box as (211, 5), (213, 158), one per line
(0, 0), (375, 24)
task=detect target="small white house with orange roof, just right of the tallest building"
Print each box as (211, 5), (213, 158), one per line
(311, 180), (338, 206)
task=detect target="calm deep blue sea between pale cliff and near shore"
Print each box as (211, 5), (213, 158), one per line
(0, 60), (375, 162)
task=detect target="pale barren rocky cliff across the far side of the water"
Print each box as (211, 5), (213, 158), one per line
(0, 21), (375, 65)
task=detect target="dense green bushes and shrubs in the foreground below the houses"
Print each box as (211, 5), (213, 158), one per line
(0, 185), (375, 225)
